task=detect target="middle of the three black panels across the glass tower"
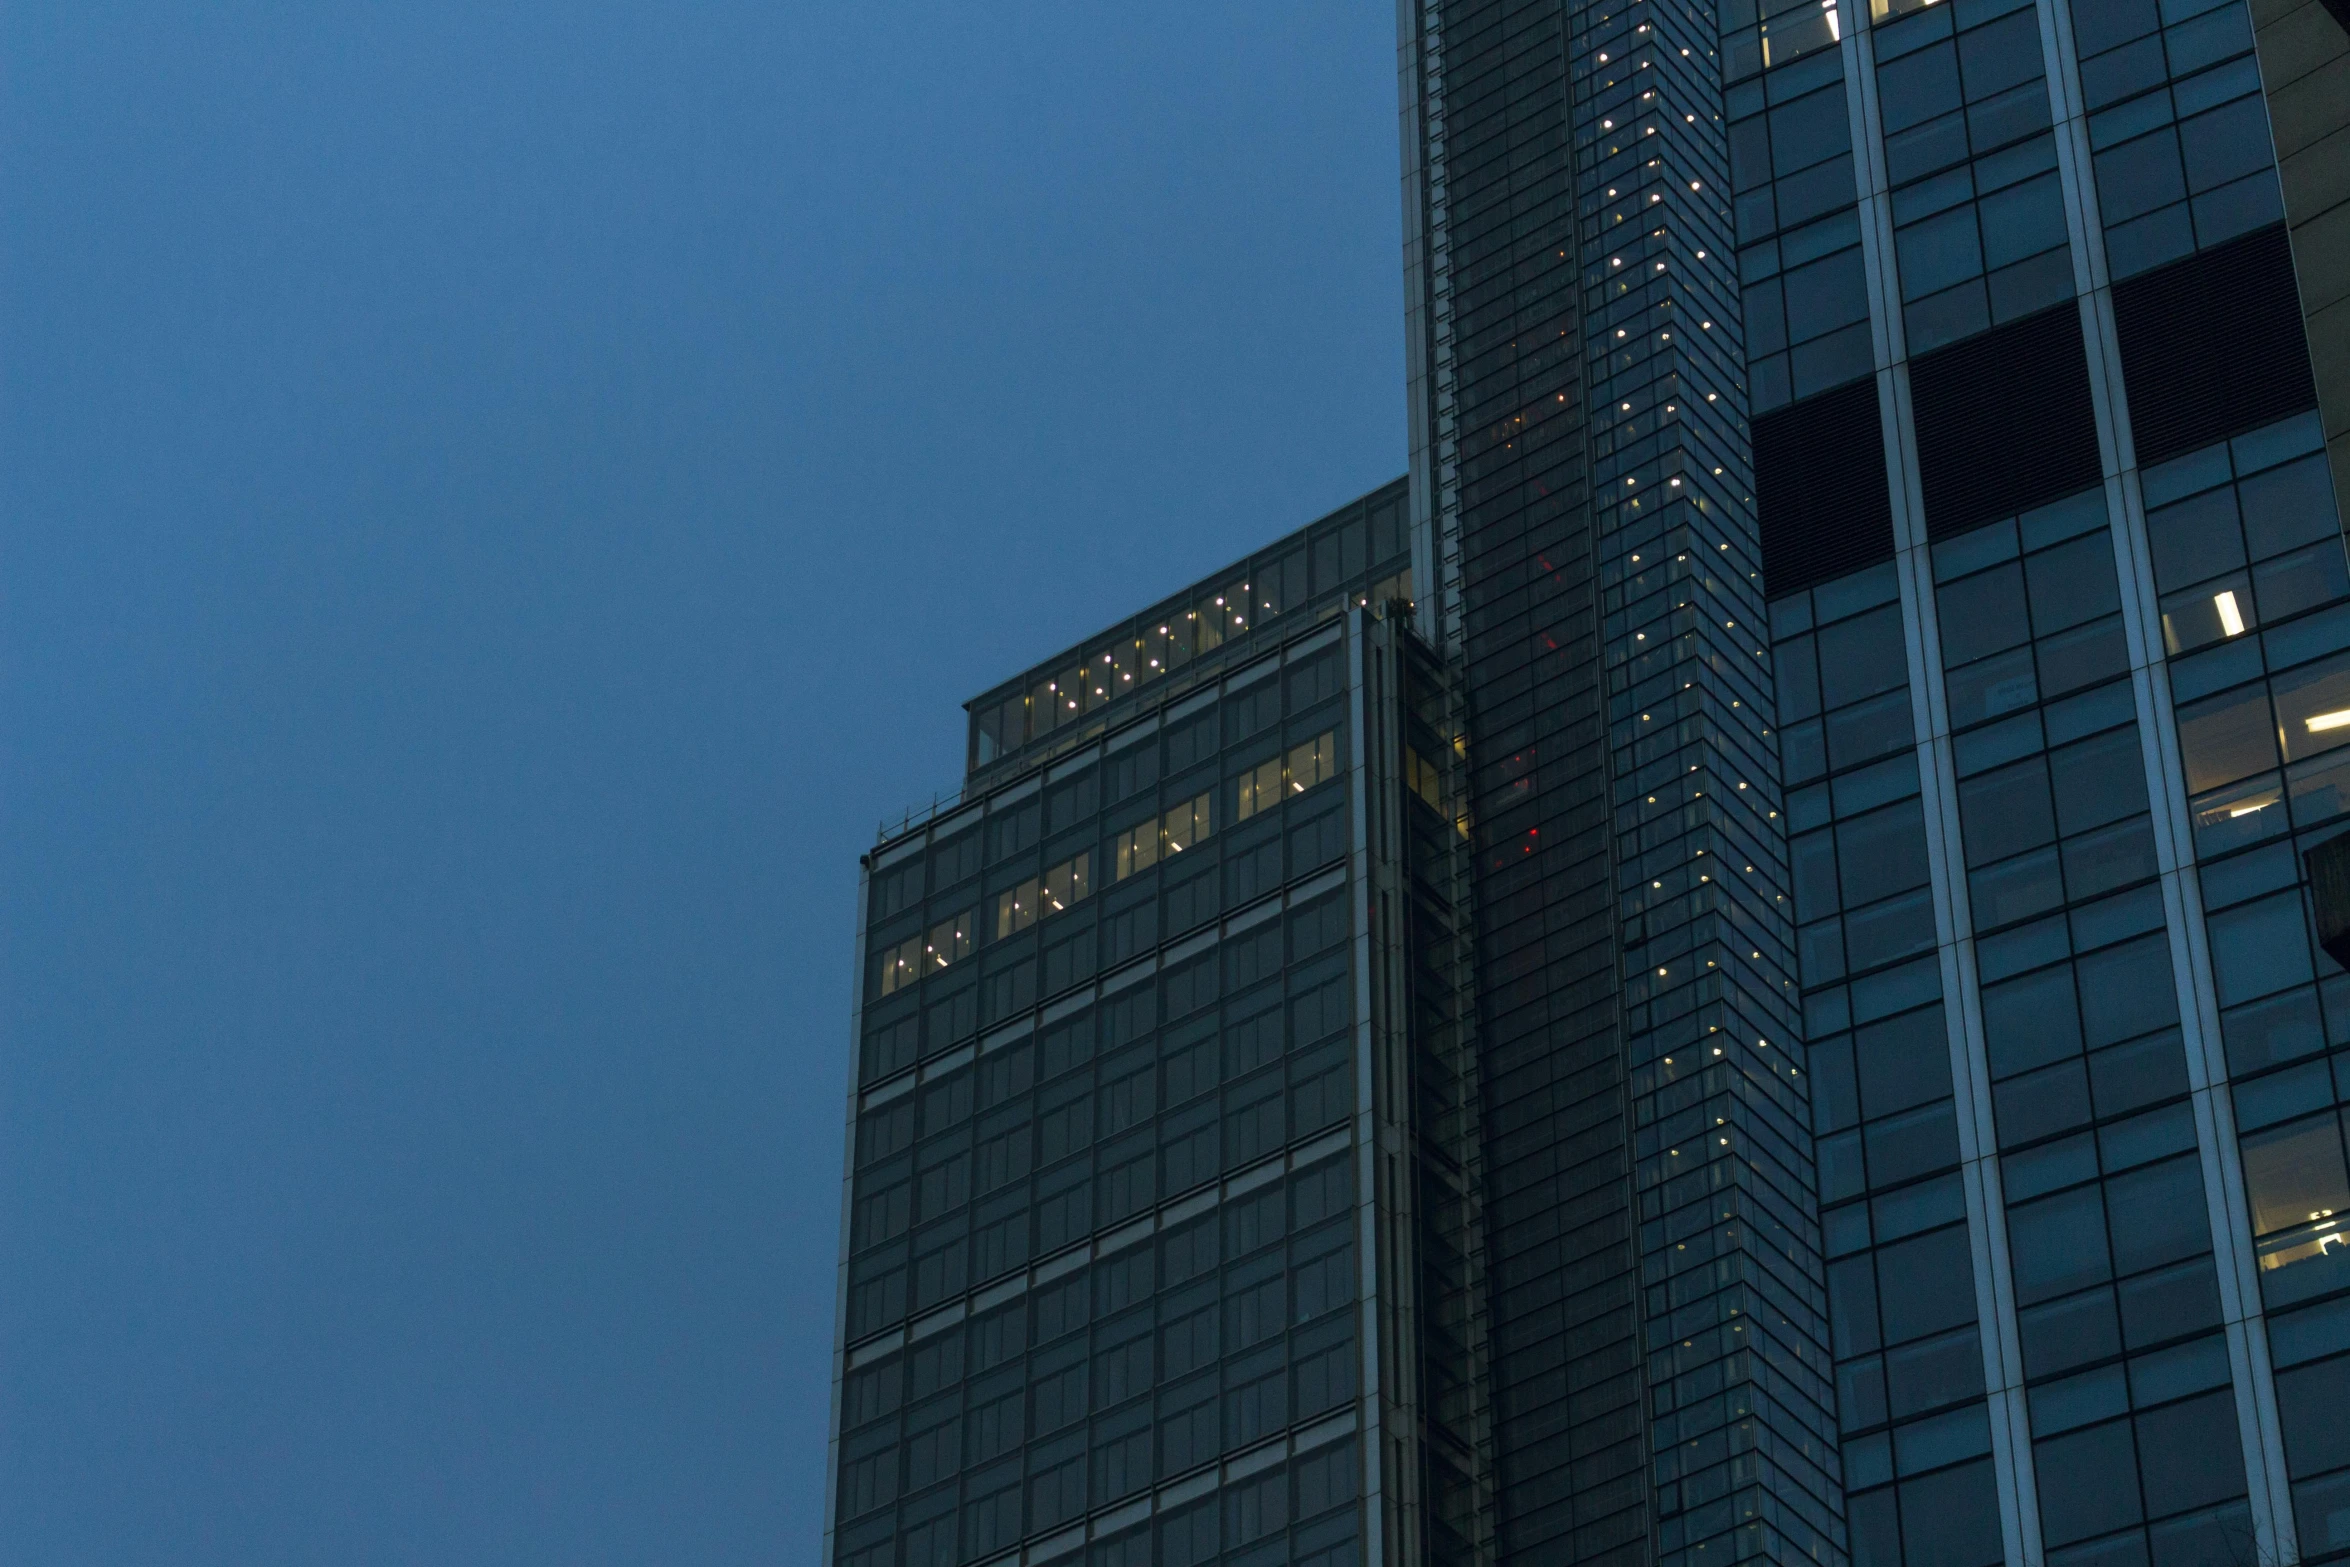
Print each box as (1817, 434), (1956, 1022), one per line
(1911, 305), (2101, 538)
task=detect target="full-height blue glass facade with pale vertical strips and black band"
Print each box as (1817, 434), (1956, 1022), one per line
(1725, 0), (2350, 1567)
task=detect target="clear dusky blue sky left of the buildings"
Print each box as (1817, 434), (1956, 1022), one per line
(0, 0), (1403, 1567)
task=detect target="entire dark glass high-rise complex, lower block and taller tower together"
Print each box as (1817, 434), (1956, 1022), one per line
(827, 0), (2350, 1567)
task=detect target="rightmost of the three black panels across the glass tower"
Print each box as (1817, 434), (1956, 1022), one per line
(2113, 226), (2317, 465)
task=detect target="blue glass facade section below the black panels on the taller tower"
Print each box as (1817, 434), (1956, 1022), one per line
(1772, 429), (2350, 1567)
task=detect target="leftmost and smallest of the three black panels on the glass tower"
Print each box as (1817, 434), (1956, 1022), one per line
(1753, 376), (1894, 594)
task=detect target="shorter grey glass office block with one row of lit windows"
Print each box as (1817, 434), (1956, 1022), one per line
(827, 486), (1490, 1567)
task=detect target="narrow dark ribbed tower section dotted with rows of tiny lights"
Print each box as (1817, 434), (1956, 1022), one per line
(1403, 0), (1832, 1565)
